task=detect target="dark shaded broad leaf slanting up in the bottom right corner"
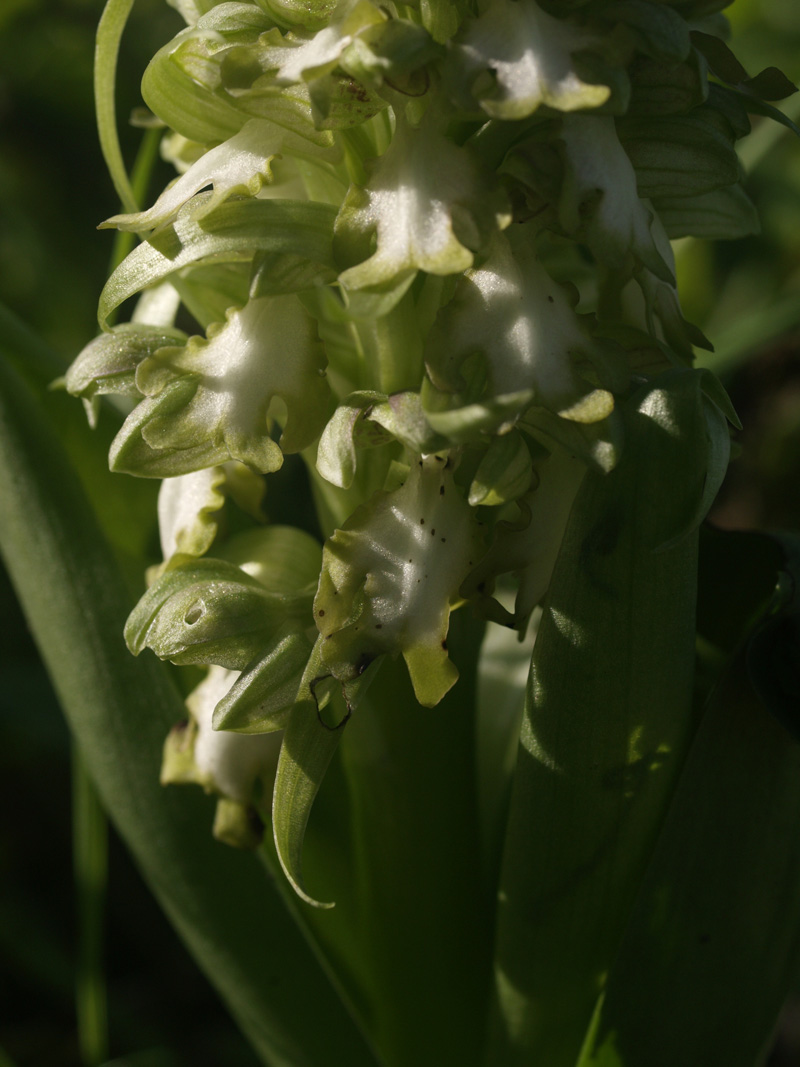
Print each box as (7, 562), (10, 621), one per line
(580, 544), (800, 1067)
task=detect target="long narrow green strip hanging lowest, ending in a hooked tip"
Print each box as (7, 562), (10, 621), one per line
(272, 637), (380, 908)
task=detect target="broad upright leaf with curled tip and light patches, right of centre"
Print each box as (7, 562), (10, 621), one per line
(486, 375), (708, 1067)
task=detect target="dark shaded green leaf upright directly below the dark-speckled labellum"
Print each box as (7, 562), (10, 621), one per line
(334, 623), (493, 1067)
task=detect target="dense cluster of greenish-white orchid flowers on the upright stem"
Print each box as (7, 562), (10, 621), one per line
(67, 0), (797, 879)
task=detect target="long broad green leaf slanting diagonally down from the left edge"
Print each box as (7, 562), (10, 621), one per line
(0, 356), (377, 1067)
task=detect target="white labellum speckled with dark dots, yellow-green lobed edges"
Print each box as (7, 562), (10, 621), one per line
(314, 455), (483, 706)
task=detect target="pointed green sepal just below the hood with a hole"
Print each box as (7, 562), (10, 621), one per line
(213, 630), (313, 734)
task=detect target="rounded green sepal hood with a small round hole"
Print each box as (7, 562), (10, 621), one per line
(125, 558), (310, 670)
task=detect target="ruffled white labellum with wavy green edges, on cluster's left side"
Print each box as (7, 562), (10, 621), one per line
(111, 296), (330, 477)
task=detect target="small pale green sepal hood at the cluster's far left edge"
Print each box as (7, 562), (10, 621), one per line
(64, 322), (187, 426)
